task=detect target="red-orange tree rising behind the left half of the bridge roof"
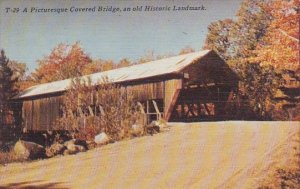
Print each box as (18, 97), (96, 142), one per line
(32, 42), (92, 83)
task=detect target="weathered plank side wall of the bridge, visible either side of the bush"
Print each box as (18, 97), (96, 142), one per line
(22, 81), (169, 131)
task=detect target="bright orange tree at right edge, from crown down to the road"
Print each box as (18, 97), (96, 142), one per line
(249, 0), (300, 120)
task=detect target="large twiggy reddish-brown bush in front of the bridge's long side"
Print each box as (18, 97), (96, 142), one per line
(57, 78), (139, 141)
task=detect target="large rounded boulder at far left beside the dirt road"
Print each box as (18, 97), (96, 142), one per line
(13, 140), (45, 160)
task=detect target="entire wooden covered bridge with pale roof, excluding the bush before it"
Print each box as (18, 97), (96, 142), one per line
(14, 50), (238, 131)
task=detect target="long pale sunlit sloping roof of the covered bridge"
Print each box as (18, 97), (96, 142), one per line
(14, 50), (211, 99)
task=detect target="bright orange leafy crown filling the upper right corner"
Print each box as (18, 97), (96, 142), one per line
(251, 0), (300, 75)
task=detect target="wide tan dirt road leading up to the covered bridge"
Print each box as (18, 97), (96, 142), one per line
(0, 122), (300, 189)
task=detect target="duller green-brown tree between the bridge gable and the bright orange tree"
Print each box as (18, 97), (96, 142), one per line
(205, 0), (281, 119)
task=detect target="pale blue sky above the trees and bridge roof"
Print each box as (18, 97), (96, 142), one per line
(0, 0), (241, 71)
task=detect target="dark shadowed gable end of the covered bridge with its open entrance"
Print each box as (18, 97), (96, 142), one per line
(167, 52), (238, 121)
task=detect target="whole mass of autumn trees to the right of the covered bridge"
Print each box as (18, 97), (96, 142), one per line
(204, 0), (300, 120)
